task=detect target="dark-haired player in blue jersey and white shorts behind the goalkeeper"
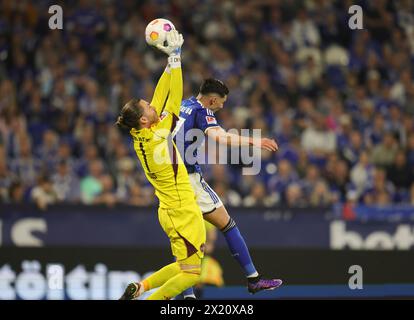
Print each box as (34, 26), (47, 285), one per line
(175, 79), (282, 298)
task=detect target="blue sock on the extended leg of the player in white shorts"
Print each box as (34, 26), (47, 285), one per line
(221, 218), (258, 277)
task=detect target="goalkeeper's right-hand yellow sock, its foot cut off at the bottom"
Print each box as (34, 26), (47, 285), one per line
(147, 254), (201, 300)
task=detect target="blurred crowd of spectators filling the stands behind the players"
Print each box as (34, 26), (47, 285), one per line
(0, 0), (414, 207)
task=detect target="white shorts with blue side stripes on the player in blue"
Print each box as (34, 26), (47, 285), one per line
(188, 172), (223, 214)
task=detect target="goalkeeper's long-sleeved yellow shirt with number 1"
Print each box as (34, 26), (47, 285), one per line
(130, 67), (196, 209)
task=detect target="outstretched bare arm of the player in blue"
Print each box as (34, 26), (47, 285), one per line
(205, 126), (279, 151)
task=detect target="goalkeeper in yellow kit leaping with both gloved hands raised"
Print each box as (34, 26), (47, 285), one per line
(117, 30), (206, 300)
